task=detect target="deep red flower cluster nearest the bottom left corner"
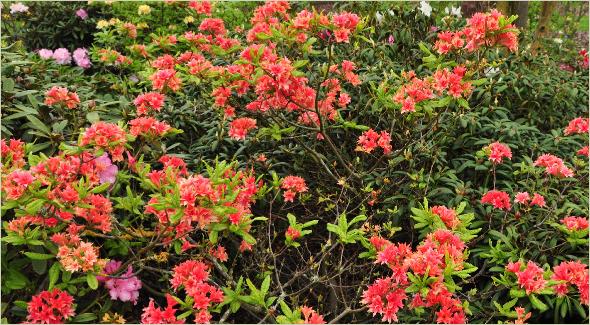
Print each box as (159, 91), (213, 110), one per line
(27, 288), (74, 324)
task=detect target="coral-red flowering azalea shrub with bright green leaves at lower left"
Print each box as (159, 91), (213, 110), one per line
(2, 121), (264, 323)
